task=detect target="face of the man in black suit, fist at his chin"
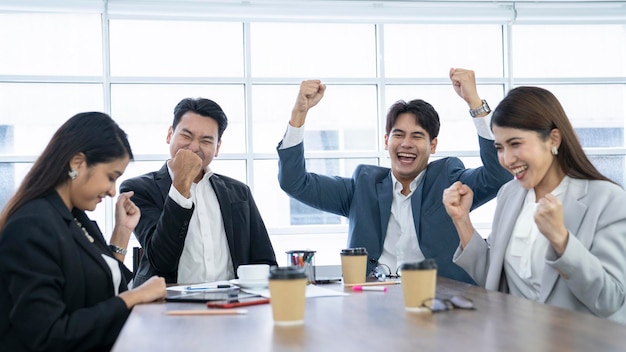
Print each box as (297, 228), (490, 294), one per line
(167, 111), (221, 170)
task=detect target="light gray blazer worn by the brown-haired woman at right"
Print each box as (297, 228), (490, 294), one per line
(453, 179), (626, 323)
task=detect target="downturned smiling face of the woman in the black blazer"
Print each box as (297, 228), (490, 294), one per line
(67, 156), (130, 211)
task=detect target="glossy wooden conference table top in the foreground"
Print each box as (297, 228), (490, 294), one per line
(113, 277), (626, 352)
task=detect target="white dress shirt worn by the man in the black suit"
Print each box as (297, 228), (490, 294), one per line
(168, 166), (235, 283)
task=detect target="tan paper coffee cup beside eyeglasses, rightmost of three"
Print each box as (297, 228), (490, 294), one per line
(400, 259), (437, 312)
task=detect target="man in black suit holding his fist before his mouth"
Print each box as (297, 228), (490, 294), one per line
(120, 98), (276, 285)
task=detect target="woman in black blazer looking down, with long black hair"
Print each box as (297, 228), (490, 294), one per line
(0, 112), (165, 351)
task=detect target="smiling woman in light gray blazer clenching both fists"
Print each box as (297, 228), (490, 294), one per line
(443, 87), (626, 323)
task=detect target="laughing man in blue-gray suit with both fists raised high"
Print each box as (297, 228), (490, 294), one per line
(277, 69), (511, 283)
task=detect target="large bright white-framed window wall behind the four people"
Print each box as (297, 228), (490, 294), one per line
(0, 0), (626, 265)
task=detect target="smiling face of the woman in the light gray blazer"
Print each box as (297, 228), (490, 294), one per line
(493, 125), (565, 199)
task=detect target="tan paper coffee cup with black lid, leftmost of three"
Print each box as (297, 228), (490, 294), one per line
(269, 267), (307, 326)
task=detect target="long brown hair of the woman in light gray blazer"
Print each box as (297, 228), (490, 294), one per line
(491, 87), (615, 183)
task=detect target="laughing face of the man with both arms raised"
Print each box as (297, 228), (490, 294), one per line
(385, 113), (437, 186)
